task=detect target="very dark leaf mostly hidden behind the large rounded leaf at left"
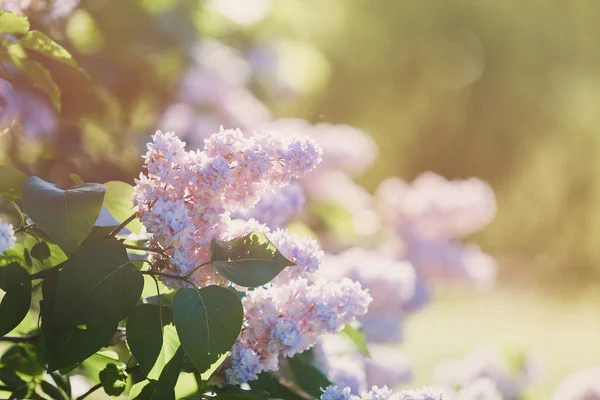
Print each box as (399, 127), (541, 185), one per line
(40, 278), (117, 371)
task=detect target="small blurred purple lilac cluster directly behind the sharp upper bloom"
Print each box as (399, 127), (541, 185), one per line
(235, 183), (306, 228)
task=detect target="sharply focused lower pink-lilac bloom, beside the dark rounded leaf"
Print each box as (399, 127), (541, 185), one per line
(225, 278), (371, 384)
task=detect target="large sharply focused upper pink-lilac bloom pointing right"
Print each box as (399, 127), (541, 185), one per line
(133, 129), (321, 286)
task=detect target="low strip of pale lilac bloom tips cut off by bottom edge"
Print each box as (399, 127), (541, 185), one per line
(321, 386), (446, 400)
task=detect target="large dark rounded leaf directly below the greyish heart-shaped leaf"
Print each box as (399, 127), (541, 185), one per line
(53, 239), (144, 326)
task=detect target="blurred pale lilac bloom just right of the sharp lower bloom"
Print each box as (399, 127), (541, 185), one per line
(321, 247), (416, 342)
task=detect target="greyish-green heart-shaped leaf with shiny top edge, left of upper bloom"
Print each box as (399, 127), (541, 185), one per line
(23, 176), (105, 254)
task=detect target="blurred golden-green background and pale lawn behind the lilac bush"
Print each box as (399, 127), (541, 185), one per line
(0, 0), (600, 399)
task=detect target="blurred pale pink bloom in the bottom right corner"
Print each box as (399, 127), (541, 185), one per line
(551, 367), (600, 400)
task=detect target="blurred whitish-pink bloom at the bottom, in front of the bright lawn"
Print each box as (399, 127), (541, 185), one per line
(435, 346), (540, 399)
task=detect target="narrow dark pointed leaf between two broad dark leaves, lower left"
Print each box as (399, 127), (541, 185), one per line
(127, 304), (163, 375)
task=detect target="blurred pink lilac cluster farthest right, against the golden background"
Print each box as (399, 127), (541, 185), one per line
(376, 172), (497, 286)
